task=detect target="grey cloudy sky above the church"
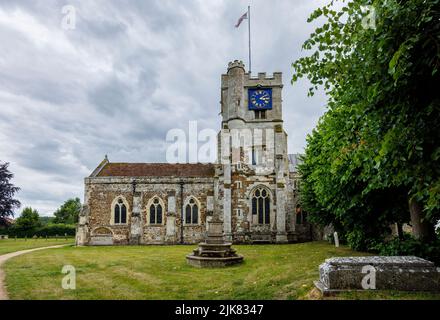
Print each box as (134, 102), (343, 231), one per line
(0, 0), (327, 215)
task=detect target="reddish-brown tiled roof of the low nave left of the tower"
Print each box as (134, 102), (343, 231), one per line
(96, 162), (215, 177)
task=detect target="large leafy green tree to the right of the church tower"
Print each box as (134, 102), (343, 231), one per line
(292, 0), (440, 249)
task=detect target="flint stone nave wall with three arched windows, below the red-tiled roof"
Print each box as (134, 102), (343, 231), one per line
(81, 177), (214, 245)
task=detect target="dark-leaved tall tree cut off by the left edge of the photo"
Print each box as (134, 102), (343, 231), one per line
(0, 162), (20, 221)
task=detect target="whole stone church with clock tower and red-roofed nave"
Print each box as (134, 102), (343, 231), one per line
(76, 60), (312, 245)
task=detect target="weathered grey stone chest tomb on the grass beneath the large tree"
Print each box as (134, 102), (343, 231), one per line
(315, 256), (440, 295)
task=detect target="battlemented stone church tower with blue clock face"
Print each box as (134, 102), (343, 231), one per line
(218, 60), (289, 242)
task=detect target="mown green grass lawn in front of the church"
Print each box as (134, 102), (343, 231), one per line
(4, 242), (440, 299)
